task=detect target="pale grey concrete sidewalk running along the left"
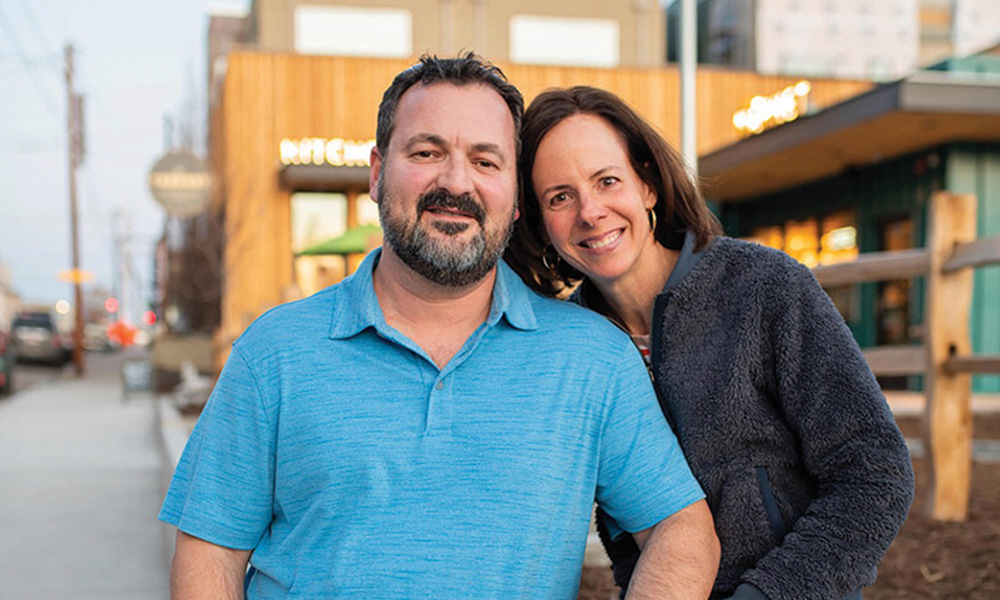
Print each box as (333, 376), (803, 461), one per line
(0, 354), (168, 600)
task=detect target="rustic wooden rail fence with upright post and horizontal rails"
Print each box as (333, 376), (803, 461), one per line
(813, 192), (1000, 521)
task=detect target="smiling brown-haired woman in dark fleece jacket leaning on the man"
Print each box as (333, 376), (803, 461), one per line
(507, 87), (913, 600)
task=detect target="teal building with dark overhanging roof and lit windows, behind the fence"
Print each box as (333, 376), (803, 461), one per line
(700, 47), (1000, 392)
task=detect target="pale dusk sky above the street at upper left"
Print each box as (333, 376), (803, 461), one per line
(0, 0), (249, 310)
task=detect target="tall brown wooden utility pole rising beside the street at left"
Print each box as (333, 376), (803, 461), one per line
(66, 44), (83, 377)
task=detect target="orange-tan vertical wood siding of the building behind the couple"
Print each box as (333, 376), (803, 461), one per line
(211, 52), (871, 361)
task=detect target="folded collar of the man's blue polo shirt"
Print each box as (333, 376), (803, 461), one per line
(330, 248), (538, 339)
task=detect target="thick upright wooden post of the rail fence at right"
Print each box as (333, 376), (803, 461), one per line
(924, 192), (977, 521)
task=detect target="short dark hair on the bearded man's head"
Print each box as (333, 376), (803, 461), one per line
(375, 52), (524, 157)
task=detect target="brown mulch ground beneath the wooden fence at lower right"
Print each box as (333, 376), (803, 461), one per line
(579, 414), (1000, 600)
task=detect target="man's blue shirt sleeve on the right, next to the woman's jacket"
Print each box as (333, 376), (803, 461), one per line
(597, 340), (705, 533)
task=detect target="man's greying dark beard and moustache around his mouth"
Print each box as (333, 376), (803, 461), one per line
(378, 173), (516, 287)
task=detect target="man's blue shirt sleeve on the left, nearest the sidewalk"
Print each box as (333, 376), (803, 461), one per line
(159, 346), (275, 550)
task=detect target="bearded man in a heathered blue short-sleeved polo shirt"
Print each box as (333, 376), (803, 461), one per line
(160, 54), (719, 600)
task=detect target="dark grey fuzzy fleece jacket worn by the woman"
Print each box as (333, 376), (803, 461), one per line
(577, 236), (913, 600)
